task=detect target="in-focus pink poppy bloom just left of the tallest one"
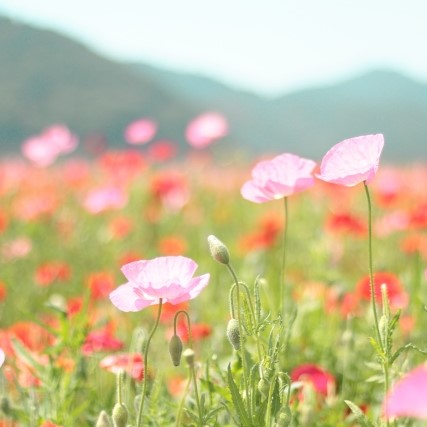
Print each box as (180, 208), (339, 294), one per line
(241, 153), (316, 203)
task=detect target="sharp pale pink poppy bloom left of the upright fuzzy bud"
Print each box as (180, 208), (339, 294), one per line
(110, 256), (210, 311)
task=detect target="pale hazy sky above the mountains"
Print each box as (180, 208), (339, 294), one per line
(0, 0), (427, 94)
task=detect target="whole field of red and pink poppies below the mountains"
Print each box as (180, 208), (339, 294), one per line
(0, 128), (427, 427)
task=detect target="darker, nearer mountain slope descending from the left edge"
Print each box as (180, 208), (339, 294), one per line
(0, 18), (198, 151)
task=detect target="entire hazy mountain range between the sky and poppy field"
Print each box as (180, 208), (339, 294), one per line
(0, 18), (427, 161)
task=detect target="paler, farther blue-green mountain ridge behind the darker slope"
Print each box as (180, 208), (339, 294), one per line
(132, 64), (427, 161)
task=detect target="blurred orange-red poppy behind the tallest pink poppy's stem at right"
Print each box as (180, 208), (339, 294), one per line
(356, 271), (408, 308)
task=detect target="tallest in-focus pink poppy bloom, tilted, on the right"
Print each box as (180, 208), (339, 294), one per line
(316, 134), (384, 187)
